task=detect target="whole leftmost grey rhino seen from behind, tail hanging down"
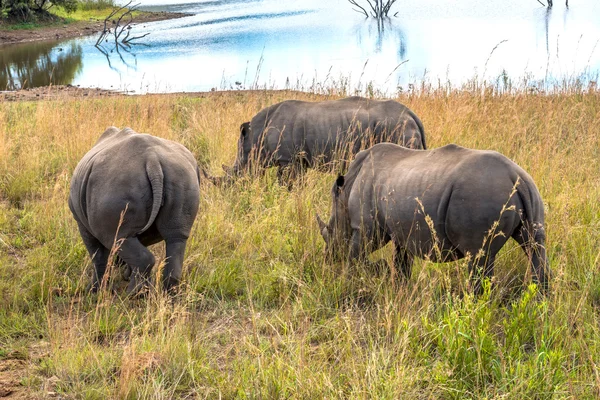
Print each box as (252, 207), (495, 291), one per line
(69, 127), (200, 294)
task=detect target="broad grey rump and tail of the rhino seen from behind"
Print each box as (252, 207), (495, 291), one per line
(69, 127), (199, 248)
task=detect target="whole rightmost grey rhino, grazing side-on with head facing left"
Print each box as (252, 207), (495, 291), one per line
(317, 143), (549, 293)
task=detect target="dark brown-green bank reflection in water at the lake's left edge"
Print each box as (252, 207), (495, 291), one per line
(0, 42), (83, 90)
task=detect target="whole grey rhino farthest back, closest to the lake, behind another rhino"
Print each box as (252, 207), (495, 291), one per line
(223, 97), (426, 176)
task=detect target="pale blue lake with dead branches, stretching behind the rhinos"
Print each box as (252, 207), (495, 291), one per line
(0, 0), (600, 94)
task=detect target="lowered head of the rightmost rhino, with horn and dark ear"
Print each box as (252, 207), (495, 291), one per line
(316, 175), (352, 260)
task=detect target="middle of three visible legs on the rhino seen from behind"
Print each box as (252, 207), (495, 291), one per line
(119, 237), (155, 296)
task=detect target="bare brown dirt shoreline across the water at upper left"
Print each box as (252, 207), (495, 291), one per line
(0, 11), (188, 48)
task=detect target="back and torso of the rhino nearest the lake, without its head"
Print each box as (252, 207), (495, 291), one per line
(251, 97), (420, 164)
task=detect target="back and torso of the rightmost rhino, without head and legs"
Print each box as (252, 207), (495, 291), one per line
(348, 144), (524, 250)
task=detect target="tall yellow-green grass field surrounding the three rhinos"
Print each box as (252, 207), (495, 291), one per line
(0, 90), (600, 399)
